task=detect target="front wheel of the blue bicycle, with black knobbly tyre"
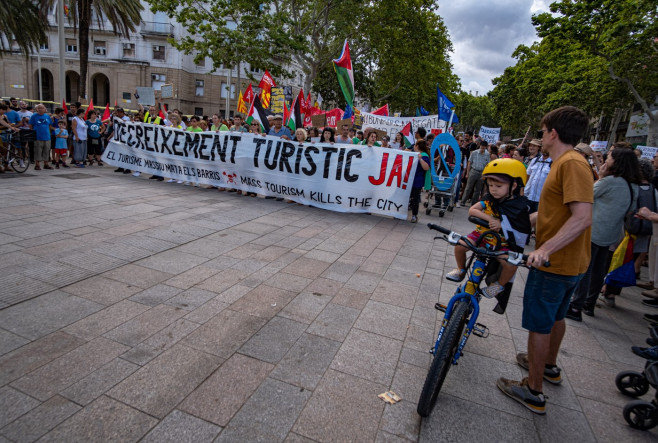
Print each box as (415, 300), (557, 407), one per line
(416, 301), (469, 417)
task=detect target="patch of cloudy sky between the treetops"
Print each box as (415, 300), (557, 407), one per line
(438, 0), (552, 94)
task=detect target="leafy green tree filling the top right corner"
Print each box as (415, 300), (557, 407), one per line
(533, 0), (658, 146)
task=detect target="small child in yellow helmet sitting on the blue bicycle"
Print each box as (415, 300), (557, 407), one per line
(446, 158), (531, 298)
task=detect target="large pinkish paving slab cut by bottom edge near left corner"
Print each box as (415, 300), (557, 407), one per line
(40, 396), (158, 442)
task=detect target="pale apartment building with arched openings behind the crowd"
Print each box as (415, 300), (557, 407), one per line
(0, 2), (304, 116)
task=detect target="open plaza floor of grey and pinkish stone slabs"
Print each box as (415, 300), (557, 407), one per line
(0, 166), (658, 443)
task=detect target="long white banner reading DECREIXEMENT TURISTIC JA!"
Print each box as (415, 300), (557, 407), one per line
(103, 119), (417, 219)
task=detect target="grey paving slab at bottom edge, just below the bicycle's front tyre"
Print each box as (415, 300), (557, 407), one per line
(419, 394), (540, 443)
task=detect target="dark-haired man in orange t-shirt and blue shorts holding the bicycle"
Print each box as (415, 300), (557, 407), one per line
(496, 106), (594, 414)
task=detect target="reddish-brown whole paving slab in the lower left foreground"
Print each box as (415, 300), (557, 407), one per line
(180, 354), (273, 426)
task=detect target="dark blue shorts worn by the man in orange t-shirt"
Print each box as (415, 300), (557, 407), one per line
(522, 268), (584, 334)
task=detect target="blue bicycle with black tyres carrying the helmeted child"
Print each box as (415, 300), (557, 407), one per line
(417, 216), (549, 417)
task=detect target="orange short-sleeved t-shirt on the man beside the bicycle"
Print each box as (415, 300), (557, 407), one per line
(536, 150), (594, 276)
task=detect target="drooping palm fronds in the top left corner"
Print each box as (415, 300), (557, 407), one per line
(0, 0), (48, 58)
